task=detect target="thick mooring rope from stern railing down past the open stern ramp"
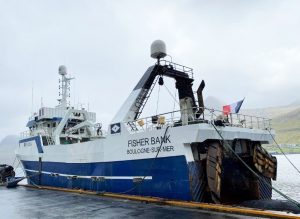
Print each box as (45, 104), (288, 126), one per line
(211, 121), (300, 208)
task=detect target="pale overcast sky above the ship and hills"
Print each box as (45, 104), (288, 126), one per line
(0, 0), (300, 139)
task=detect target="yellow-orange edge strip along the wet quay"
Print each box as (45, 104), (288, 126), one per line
(21, 185), (300, 219)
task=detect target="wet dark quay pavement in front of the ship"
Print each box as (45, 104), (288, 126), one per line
(0, 186), (257, 219)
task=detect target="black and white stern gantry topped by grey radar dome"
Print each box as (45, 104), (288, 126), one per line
(111, 40), (196, 124)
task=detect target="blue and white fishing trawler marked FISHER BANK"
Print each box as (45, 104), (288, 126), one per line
(16, 40), (277, 203)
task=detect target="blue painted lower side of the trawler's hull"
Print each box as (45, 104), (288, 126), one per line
(22, 156), (192, 201)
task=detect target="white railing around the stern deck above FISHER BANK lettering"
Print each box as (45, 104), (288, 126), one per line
(125, 107), (271, 133)
